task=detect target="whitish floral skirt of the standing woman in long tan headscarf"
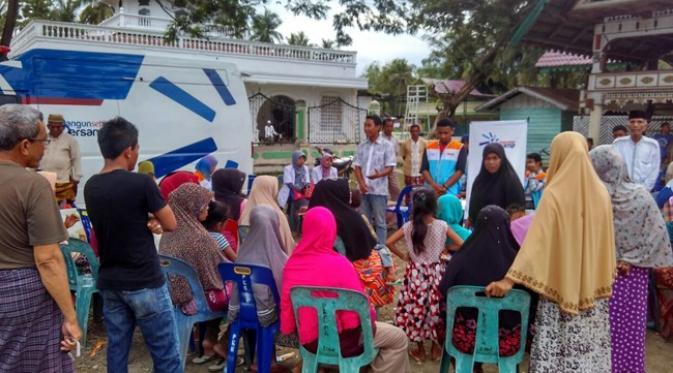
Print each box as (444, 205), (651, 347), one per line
(528, 298), (612, 373)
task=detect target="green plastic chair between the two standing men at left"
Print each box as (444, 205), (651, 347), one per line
(61, 238), (100, 346)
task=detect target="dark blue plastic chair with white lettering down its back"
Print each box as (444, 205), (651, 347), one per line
(218, 263), (280, 373)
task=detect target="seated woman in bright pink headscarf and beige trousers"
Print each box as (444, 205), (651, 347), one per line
(280, 207), (411, 373)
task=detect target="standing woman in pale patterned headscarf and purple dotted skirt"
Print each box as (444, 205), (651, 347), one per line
(589, 145), (673, 373)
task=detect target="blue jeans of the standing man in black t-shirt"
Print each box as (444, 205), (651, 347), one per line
(100, 284), (183, 373)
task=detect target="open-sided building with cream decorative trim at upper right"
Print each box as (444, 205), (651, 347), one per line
(519, 0), (673, 142)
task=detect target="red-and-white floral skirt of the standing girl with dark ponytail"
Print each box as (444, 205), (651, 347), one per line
(395, 262), (446, 344)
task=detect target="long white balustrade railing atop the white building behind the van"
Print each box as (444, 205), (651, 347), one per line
(11, 21), (356, 66)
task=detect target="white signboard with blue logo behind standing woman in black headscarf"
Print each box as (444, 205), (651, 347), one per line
(465, 120), (528, 216)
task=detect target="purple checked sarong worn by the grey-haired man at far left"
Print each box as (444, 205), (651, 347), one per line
(0, 268), (74, 373)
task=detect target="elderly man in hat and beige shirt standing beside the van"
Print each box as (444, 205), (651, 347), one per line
(40, 114), (82, 203)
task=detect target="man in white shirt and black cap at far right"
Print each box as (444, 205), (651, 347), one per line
(613, 110), (661, 191)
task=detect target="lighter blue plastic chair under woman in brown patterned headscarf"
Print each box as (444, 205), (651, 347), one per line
(159, 255), (227, 368)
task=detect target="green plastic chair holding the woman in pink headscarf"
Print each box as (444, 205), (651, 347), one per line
(290, 286), (378, 373)
